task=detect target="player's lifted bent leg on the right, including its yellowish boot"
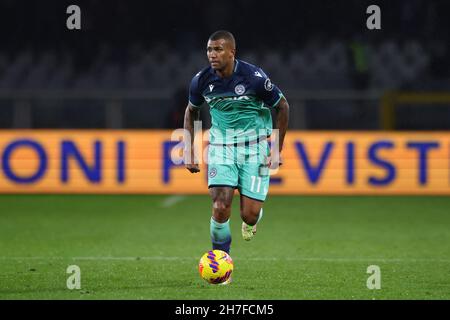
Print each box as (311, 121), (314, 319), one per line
(240, 195), (264, 241)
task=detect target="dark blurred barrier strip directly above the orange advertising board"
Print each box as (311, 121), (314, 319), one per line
(0, 90), (450, 130)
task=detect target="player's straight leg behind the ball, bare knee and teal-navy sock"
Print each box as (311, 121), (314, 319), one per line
(209, 187), (234, 253)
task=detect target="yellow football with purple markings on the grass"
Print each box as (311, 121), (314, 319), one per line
(198, 250), (233, 284)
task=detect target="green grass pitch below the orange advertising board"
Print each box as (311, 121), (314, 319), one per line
(0, 195), (450, 300)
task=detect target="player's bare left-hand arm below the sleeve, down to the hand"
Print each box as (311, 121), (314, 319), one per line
(184, 102), (200, 173)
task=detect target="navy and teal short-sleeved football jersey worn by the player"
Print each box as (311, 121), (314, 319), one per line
(189, 59), (283, 144)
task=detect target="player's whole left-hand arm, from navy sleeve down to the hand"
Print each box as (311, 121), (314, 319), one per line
(184, 72), (205, 173)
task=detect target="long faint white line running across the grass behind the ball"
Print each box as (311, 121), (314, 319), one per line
(0, 256), (450, 263)
